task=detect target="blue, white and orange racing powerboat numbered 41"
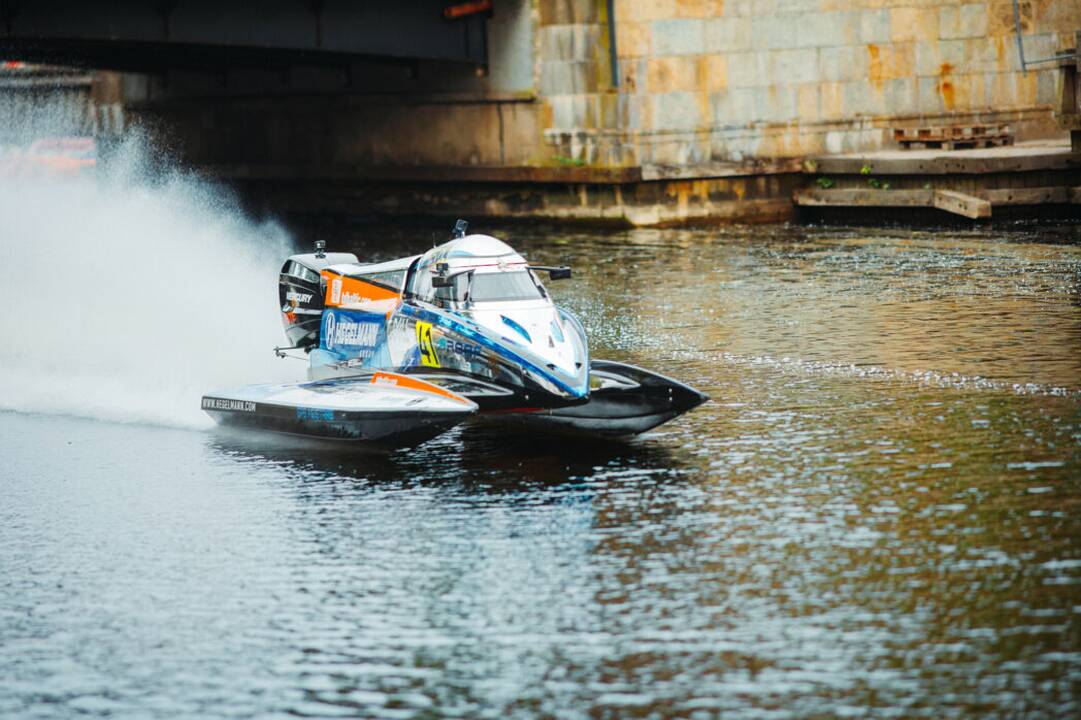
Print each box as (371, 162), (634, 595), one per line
(203, 221), (708, 445)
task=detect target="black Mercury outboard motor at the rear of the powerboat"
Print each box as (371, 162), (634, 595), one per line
(278, 240), (357, 349)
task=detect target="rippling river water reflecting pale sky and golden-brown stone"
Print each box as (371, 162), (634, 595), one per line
(0, 225), (1081, 718)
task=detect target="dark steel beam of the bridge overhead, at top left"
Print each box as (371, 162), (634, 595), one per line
(0, 0), (490, 72)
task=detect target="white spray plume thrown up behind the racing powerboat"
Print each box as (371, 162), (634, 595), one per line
(0, 127), (304, 427)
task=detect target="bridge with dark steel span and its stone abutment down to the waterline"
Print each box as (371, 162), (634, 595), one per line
(0, 0), (1081, 225)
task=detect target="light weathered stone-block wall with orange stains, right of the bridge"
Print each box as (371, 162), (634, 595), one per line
(536, 0), (1081, 164)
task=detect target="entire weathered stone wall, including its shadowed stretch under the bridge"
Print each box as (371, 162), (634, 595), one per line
(125, 0), (1081, 182)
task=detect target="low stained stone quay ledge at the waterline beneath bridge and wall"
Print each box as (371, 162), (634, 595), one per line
(203, 160), (805, 227)
